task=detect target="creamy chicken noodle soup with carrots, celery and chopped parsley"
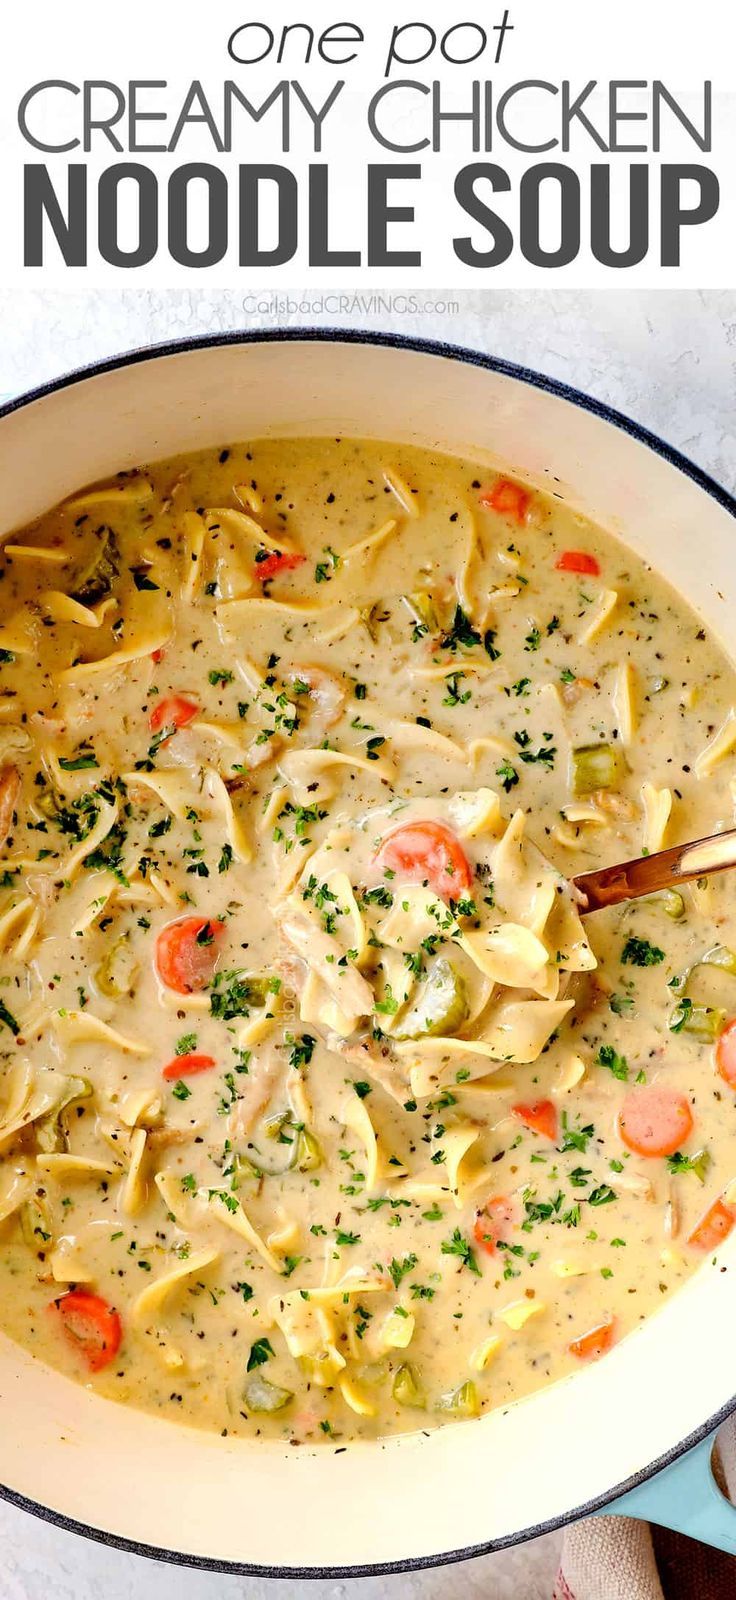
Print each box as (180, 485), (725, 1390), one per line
(0, 440), (736, 1443)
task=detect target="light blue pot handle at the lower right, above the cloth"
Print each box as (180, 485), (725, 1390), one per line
(600, 1434), (736, 1555)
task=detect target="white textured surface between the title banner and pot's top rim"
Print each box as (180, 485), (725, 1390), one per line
(0, 290), (736, 486)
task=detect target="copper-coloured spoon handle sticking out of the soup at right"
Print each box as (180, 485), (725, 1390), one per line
(573, 827), (736, 915)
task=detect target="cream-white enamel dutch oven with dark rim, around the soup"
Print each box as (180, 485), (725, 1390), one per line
(0, 331), (736, 1576)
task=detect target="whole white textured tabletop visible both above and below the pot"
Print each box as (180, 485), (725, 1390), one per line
(0, 290), (736, 1600)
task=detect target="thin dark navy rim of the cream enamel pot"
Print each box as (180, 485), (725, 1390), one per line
(0, 326), (736, 1579)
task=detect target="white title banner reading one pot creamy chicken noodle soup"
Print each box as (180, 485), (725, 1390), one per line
(0, 0), (736, 293)
